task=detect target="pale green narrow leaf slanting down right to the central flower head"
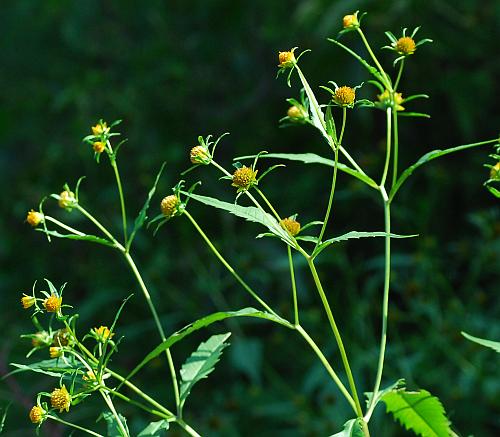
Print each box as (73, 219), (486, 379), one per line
(184, 193), (295, 247)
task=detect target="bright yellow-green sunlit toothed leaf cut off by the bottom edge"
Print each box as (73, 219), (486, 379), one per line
(382, 388), (451, 437)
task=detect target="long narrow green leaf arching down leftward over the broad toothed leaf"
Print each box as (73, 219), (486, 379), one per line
(121, 308), (292, 380)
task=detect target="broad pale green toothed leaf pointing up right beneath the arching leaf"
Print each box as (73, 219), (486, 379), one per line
(180, 332), (231, 408)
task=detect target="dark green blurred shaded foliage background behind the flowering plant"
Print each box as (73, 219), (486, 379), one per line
(0, 0), (500, 436)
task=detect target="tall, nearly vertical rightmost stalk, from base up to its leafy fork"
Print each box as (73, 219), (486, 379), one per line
(367, 186), (391, 415)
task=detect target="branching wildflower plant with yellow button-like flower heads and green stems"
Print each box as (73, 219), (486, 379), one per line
(8, 12), (500, 437)
